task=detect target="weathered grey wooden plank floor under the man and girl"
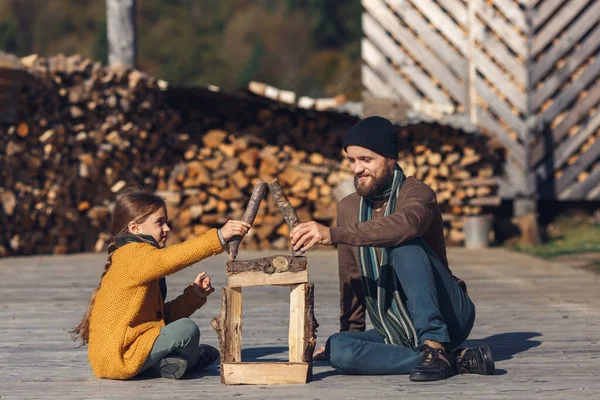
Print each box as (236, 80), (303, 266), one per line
(0, 249), (600, 399)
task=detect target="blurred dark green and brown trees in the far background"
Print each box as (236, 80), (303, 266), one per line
(0, 0), (361, 98)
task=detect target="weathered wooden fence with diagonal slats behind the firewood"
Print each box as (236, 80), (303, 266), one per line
(362, 0), (600, 200)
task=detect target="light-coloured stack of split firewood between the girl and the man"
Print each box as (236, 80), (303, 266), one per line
(152, 130), (352, 249)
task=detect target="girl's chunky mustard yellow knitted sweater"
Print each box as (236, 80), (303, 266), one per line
(88, 229), (223, 379)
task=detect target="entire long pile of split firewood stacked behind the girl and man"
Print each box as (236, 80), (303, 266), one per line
(0, 56), (502, 256)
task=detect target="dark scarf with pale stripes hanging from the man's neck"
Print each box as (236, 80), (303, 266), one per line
(358, 165), (418, 348)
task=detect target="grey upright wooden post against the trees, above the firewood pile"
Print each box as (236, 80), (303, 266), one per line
(106, 0), (137, 68)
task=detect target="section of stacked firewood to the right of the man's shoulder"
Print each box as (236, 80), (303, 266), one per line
(399, 125), (504, 244)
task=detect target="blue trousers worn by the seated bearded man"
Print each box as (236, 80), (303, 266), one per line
(325, 238), (475, 375)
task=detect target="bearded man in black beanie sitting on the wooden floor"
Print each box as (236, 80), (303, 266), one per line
(291, 117), (494, 381)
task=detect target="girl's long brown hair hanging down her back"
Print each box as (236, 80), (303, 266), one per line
(71, 188), (167, 345)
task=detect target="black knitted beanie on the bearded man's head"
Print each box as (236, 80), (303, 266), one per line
(344, 117), (398, 160)
